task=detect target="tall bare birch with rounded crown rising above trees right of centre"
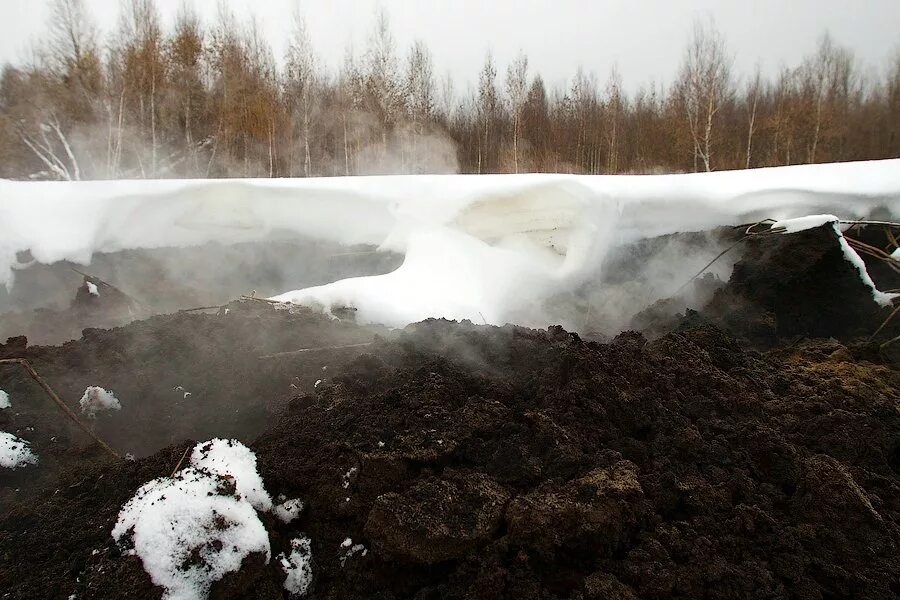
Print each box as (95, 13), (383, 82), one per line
(678, 20), (732, 171)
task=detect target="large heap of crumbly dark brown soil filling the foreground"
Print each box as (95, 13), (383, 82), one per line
(0, 315), (900, 598)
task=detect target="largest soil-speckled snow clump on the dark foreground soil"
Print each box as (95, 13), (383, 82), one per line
(112, 439), (271, 600)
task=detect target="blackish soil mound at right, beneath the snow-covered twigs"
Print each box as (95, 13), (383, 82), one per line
(632, 225), (900, 349)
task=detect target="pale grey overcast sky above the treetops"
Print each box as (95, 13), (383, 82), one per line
(0, 0), (900, 90)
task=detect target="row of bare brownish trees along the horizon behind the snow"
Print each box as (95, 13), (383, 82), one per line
(0, 0), (900, 180)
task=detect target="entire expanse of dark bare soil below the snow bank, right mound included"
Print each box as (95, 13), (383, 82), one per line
(0, 223), (900, 599)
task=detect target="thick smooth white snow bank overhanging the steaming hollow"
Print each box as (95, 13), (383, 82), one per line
(0, 160), (900, 326)
